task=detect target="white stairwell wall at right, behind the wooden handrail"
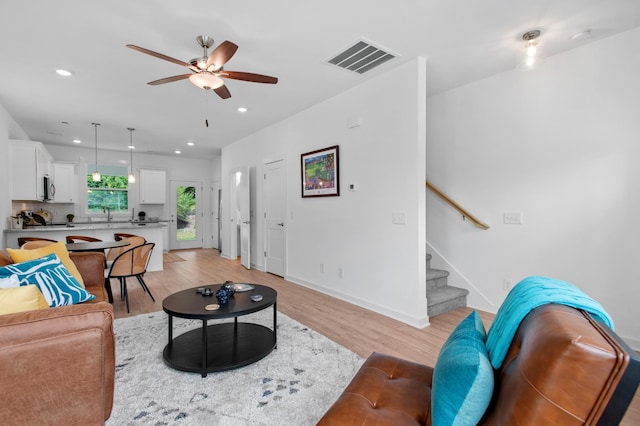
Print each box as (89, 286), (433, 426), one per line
(427, 25), (640, 347)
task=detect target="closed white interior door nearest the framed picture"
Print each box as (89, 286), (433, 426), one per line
(264, 160), (286, 277)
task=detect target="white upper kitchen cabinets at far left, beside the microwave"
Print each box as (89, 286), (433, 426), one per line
(9, 140), (55, 201)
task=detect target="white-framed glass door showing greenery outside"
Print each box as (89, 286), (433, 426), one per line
(169, 181), (203, 249)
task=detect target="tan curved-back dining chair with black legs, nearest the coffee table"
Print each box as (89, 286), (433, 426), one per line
(105, 243), (156, 312)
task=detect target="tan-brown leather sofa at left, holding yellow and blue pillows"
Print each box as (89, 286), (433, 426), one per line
(0, 251), (115, 425)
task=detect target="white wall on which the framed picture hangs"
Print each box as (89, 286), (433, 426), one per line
(221, 59), (428, 326)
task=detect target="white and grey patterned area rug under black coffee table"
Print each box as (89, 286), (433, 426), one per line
(107, 308), (364, 426)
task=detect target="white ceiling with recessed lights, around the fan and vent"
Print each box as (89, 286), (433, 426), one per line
(0, 0), (640, 158)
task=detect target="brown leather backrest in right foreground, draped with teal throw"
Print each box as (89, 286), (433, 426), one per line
(483, 304), (640, 425)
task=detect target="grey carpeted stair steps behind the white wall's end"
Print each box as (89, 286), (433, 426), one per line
(427, 254), (469, 318)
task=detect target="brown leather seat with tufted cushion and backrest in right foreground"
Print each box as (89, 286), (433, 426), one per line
(318, 304), (640, 426)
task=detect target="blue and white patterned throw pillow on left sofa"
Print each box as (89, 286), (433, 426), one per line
(0, 253), (96, 308)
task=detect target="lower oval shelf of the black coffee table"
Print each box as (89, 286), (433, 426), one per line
(163, 319), (276, 377)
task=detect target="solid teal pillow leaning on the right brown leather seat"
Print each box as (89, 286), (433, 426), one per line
(431, 311), (494, 426)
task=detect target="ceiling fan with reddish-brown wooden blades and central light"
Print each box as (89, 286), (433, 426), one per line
(127, 35), (278, 99)
